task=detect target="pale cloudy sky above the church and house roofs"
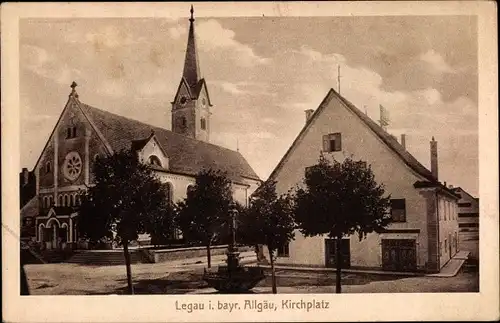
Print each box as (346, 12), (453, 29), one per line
(19, 8), (479, 196)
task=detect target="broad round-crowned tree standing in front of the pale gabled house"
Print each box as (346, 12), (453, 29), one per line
(294, 155), (390, 293)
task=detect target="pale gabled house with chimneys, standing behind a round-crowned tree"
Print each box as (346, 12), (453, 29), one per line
(270, 90), (458, 272)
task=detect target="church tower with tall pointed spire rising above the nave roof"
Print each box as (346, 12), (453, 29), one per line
(172, 6), (212, 142)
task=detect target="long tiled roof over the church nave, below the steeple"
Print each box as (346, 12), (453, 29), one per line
(80, 103), (259, 181)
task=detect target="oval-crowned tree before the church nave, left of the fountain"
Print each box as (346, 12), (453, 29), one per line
(177, 169), (233, 268)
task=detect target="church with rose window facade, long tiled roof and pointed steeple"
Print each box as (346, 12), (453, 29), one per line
(20, 7), (261, 249)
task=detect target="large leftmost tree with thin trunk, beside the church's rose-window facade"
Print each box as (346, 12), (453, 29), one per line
(78, 151), (173, 294)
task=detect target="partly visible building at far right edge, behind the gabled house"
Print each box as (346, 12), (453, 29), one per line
(453, 187), (479, 260)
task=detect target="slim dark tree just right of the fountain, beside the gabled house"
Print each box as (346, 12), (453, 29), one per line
(239, 180), (295, 294)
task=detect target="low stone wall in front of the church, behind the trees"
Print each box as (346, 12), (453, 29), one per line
(148, 245), (253, 263)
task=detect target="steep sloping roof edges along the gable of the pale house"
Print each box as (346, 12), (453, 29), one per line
(270, 89), (438, 183)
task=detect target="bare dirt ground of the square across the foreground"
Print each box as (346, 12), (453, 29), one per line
(25, 264), (479, 295)
